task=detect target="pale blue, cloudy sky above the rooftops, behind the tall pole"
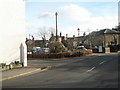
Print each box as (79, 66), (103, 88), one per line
(25, 1), (118, 39)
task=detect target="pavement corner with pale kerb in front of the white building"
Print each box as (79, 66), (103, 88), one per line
(0, 64), (51, 81)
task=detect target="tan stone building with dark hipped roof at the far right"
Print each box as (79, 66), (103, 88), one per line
(86, 29), (120, 47)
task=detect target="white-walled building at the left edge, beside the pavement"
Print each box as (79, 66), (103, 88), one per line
(0, 0), (27, 66)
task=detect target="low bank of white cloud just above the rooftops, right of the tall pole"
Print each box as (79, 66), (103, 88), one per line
(59, 16), (118, 37)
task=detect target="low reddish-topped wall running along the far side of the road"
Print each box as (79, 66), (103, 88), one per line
(27, 50), (92, 58)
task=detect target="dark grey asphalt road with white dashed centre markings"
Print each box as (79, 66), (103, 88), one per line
(2, 54), (118, 88)
